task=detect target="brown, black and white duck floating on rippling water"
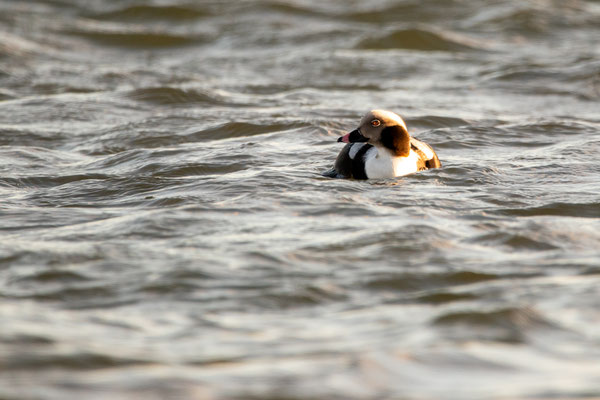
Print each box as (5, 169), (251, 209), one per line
(323, 110), (442, 179)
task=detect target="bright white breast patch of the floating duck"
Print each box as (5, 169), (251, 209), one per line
(365, 147), (419, 179)
